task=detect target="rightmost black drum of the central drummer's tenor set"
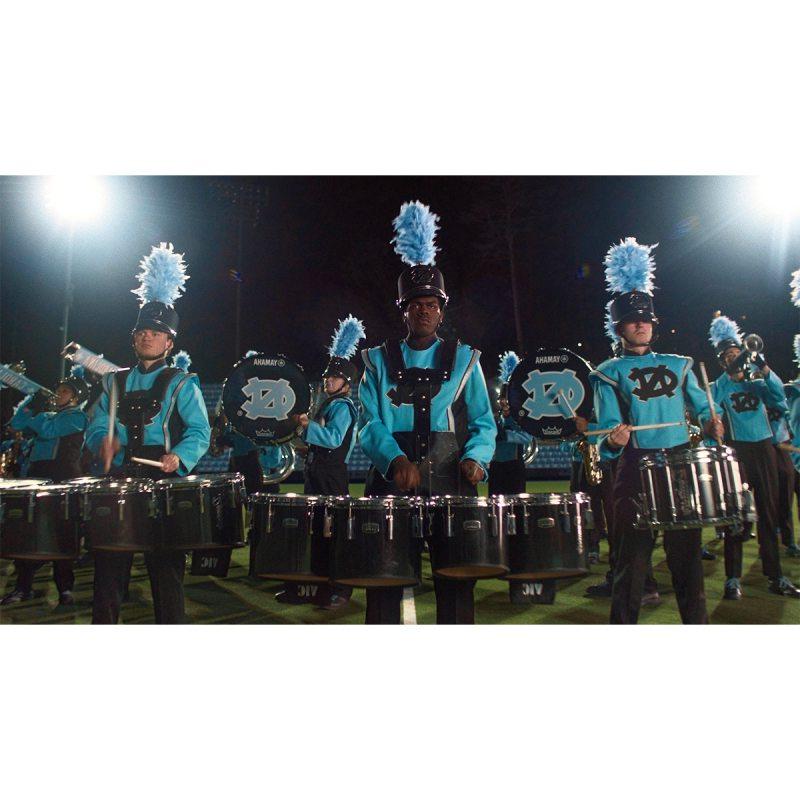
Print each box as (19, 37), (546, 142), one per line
(504, 492), (590, 581)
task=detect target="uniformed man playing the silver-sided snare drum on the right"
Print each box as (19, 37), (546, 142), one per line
(591, 237), (723, 624)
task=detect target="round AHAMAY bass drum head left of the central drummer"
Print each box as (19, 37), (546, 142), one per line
(222, 353), (311, 444)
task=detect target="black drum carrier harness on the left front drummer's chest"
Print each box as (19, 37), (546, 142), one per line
(112, 367), (191, 477)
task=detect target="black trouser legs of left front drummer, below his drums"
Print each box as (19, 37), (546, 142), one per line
(92, 550), (186, 625)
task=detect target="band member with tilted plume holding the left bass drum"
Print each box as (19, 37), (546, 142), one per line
(286, 314), (366, 608)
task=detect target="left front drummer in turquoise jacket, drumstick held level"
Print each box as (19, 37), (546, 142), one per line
(86, 244), (211, 623)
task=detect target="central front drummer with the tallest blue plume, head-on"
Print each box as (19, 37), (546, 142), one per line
(358, 201), (497, 624)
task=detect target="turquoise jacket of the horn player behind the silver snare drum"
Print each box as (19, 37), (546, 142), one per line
(711, 370), (788, 442)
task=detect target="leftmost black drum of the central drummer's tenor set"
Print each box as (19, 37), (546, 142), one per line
(250, 492), (331, 583)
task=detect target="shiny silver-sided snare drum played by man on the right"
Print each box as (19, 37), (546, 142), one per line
(637, 447), (747, 530)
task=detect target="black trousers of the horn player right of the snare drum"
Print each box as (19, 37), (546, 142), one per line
(724, 439), (782, 580)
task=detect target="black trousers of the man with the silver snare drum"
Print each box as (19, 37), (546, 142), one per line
(610, 446), (708, 624)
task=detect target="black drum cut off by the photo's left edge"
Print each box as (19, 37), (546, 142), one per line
(0, 480), (80, 561)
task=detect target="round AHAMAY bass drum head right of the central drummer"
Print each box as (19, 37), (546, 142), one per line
(508, 347), (593, 439)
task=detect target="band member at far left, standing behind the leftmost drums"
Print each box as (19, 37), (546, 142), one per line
(0, 367), (89, 607)
